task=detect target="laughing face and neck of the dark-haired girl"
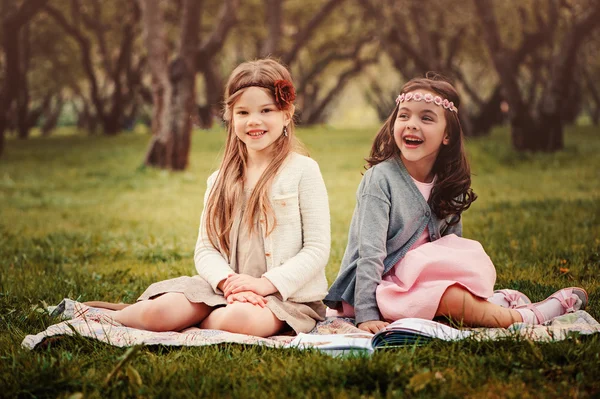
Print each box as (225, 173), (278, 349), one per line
(394, 90), (449, 181)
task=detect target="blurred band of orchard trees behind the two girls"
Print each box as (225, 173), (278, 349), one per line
(0, 0), (600, 170)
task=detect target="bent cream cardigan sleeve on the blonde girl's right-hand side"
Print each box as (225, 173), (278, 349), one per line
(263, 161), (331, 301)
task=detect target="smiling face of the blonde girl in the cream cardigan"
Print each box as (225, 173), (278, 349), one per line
(233, 87), (290, 156)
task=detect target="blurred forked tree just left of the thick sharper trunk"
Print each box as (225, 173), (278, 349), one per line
(44, 0), (145, 135)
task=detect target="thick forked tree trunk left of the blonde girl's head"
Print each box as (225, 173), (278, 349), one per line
(140, 0), (237, 170)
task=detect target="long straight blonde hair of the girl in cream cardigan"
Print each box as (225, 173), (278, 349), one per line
(204, 59), (305, 257)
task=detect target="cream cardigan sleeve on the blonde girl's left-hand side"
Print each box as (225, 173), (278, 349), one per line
(194, 171), (234, 293)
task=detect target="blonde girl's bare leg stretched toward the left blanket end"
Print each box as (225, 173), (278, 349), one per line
(111, 292), (212, 331)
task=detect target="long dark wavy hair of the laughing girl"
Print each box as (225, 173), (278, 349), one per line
(365, 73), (477, 224)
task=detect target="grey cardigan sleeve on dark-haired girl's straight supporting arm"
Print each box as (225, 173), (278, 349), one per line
(354, 190), (391, 324)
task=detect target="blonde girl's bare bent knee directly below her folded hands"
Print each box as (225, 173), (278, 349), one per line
(200, 302), (285, 337)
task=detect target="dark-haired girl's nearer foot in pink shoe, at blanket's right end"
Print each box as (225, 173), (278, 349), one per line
(515, 287), (588, 324)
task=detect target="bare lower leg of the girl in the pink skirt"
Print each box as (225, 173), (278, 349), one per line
(435, 285), (523, 328)
